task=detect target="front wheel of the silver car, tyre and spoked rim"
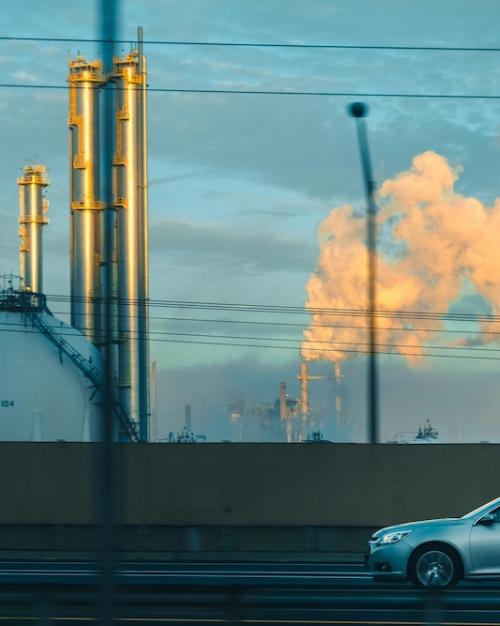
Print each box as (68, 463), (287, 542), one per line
(408, 545), (462, 589)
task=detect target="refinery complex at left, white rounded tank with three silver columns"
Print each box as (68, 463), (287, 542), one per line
(0, 37), (150, 441)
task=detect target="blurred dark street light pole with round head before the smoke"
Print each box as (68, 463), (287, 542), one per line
(348, 102), (379, 443)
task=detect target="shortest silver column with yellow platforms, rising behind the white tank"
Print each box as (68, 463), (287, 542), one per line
(17, 165), (49, 293)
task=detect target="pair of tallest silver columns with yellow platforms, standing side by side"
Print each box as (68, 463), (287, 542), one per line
(68, 44), (149, 441)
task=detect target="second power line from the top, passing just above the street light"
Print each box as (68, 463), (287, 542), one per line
(0, 83), (500, 100)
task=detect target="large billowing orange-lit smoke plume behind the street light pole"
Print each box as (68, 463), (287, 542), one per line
(302, 152), (500, 364)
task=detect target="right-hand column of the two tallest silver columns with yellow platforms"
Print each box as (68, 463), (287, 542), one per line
(113, 51), (149, 441)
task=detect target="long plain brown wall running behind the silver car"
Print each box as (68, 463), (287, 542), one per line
(0, 443), (500, 528)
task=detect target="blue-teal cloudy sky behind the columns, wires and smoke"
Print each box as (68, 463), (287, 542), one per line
(0, 0), (500, 441)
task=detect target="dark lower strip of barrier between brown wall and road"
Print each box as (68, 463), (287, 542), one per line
(0, 525), (373, 560)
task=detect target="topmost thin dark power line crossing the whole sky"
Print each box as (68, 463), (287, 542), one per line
(0, 36), (500, 52)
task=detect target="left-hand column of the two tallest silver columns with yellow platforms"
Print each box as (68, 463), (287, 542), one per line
(68, 55), (104, 345)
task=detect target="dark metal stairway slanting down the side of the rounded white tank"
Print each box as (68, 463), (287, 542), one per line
(30, 309), (139, 443)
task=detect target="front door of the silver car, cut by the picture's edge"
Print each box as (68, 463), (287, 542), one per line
(470, 507), (500, 576)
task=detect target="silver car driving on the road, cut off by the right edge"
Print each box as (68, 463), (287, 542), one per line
(366, 498), (500, 587)
